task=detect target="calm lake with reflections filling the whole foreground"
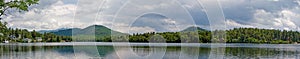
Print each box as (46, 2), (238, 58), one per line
(0, 42), (300, 59)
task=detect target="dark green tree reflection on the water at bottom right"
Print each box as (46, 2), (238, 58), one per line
(225, 47), (299, 59)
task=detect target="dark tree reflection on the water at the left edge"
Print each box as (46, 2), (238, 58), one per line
(0, 46), (74, 59)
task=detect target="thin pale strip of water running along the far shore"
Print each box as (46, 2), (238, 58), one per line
(0, 42), (300, 49)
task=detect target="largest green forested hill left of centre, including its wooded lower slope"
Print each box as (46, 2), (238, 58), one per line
(50, 25), (124, 42)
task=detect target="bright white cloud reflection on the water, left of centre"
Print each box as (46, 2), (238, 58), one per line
(105, 47), (166, 59)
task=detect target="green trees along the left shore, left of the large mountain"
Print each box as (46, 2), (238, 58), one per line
(0, 22), (71, 43)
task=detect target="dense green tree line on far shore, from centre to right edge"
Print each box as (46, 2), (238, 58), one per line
(96, 28), (300, 44)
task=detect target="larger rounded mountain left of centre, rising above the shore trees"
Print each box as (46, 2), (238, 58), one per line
(51, 25), (123, 37)
